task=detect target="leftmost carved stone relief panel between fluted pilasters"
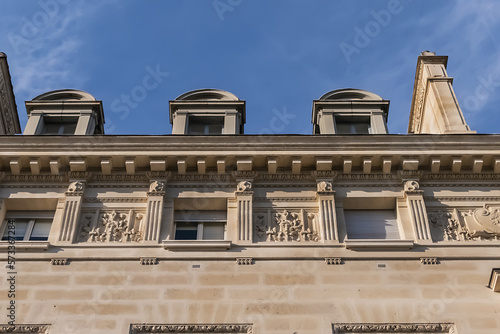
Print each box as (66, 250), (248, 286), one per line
(79, 210), (145, 242)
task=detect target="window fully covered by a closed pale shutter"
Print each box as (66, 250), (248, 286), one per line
(344, 210), (400, 239)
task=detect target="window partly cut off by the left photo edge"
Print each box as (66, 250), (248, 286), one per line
(2, 217), (52, 241)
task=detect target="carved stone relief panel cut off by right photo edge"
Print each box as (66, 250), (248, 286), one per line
(428, 205), (500, 241)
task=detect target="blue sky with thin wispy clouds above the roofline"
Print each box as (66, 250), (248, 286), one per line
(0, 0), (500, 134)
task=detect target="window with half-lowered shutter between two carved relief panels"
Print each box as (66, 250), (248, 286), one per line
(174, 211), (227, 240)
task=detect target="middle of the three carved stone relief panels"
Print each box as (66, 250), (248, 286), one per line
(254, 210), (319, 242)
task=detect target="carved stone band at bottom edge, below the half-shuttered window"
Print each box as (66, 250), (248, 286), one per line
(130, 324), (253, 334)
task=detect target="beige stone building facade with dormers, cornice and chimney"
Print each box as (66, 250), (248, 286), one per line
(0, 52), (500, 334)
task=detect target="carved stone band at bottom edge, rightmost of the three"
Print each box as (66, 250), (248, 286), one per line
(333, 323), (455, 334)
